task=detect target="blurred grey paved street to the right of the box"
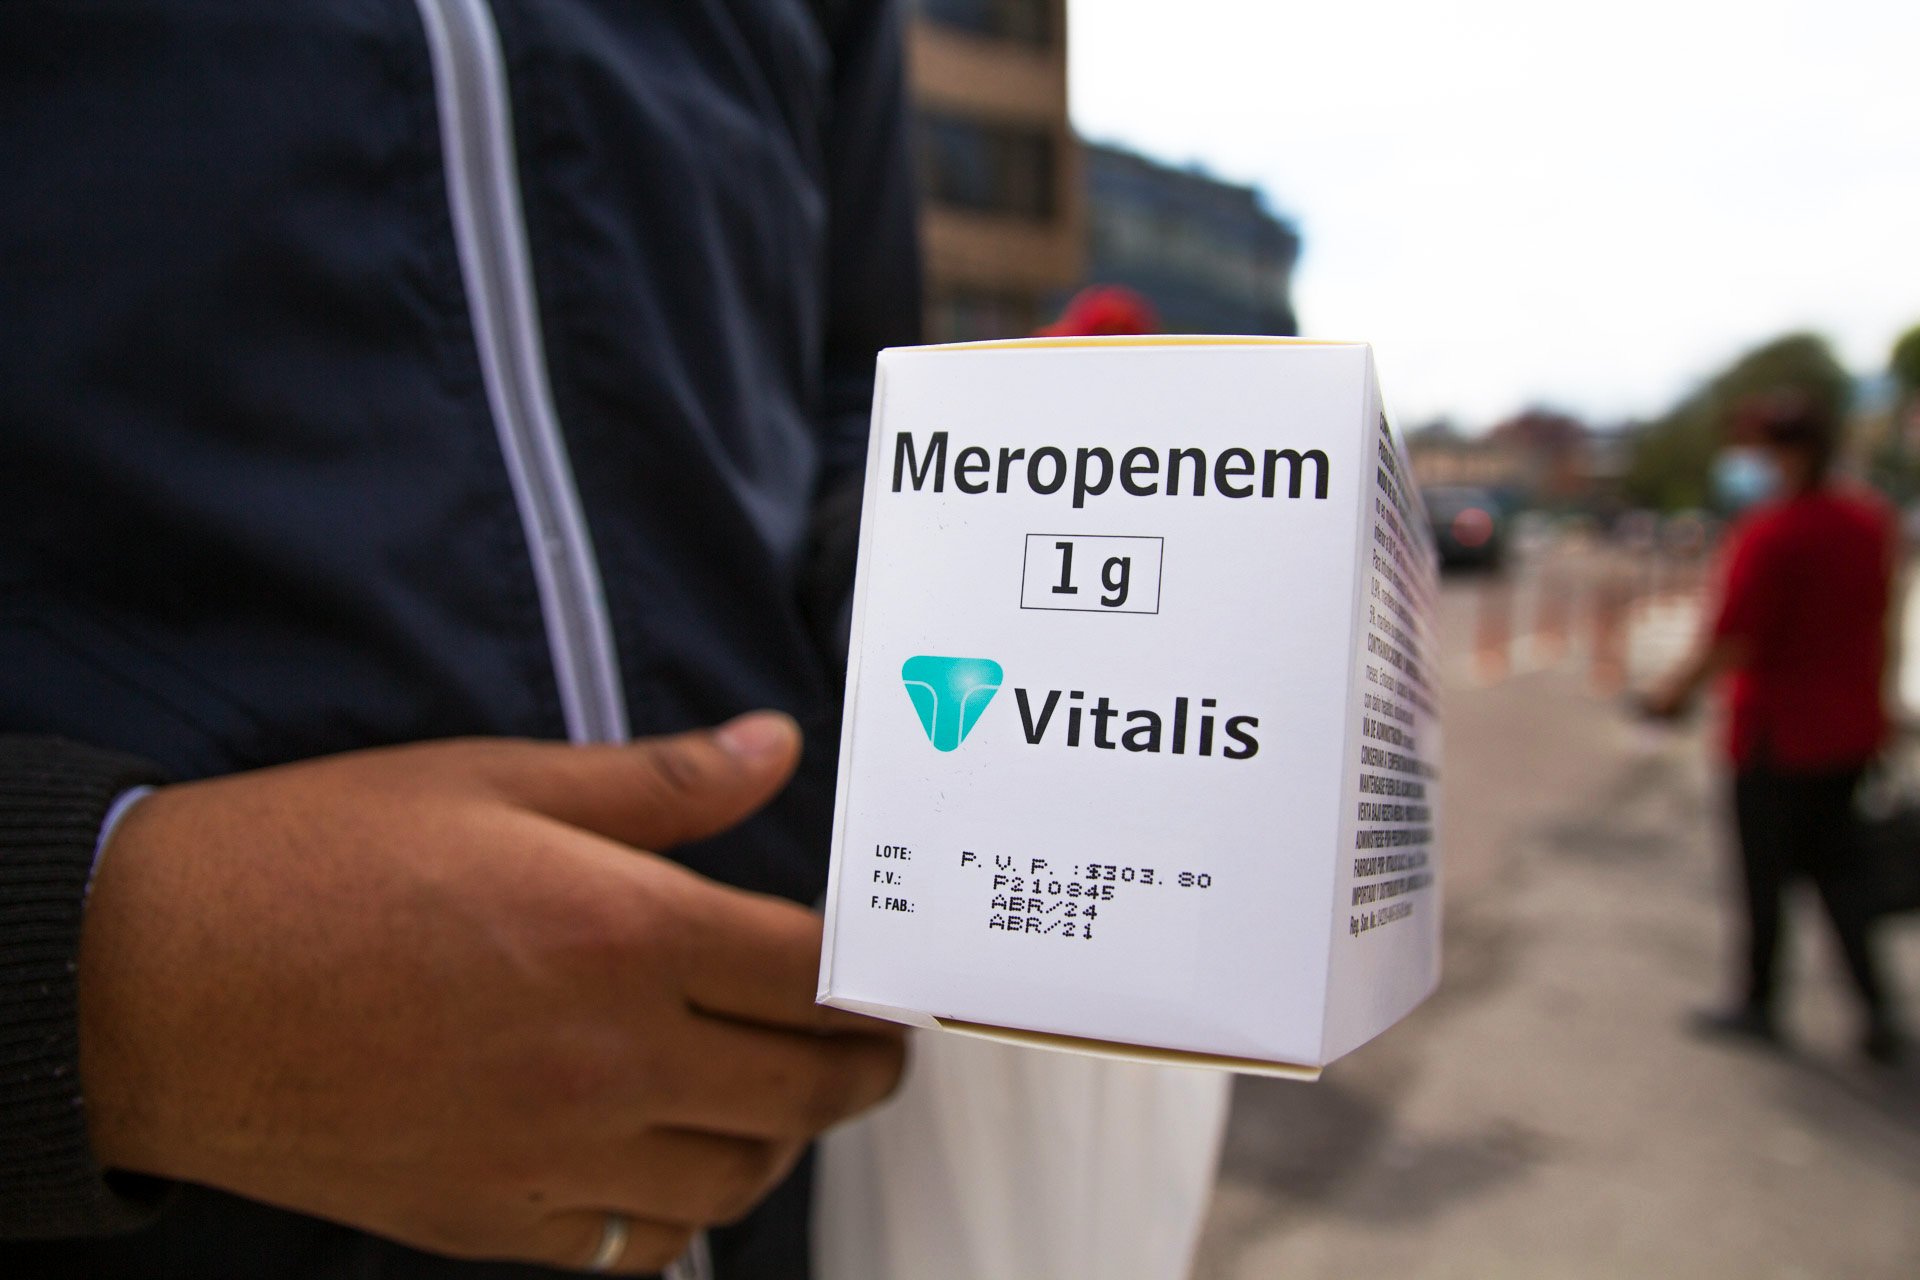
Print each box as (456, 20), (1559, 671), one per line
(1194, 553), (1920, 1280)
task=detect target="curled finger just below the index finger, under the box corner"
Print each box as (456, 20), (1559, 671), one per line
(647, 1019), (906, 1140)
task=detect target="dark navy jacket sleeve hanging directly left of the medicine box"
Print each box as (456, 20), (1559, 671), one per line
(803, 0), (920, 658)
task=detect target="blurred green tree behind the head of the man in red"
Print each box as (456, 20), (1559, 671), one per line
(1624, 334), (1853, 510)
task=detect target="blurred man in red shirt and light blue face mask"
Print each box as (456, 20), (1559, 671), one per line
(1647, 391), (1903, 1063)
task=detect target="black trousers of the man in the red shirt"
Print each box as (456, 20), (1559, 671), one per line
(1734, 766), (1889, 1025)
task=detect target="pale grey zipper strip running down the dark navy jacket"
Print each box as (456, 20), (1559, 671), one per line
(415, 0), (628, 743)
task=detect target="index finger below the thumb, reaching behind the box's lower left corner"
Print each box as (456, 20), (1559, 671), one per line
(685, 885), (887, 1034)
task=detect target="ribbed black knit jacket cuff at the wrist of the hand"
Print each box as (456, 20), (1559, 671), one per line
(0, 735), (165, 1238)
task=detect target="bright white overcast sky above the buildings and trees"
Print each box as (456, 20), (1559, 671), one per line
(1069, 0), (1920, 428)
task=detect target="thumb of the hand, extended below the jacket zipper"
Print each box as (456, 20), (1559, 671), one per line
(495, 712), (801, 850)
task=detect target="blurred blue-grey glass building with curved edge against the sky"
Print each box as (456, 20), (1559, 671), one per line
(1083, 142), (1300, 334)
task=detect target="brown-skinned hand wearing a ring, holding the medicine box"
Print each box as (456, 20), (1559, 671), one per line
(79, 714), (902, 1274)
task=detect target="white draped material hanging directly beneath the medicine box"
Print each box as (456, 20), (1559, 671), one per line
(814, 1032), (1231, 1280)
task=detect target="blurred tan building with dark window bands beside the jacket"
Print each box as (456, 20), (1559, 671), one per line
(908, 0), (1085, 342)
